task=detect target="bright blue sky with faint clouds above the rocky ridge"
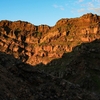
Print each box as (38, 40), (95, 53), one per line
(0, 0), (100, 26)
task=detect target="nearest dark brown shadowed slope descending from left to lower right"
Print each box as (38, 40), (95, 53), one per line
(0, 52), (99, 100)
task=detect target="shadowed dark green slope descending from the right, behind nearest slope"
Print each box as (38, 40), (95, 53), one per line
(38, 40), (100, 93)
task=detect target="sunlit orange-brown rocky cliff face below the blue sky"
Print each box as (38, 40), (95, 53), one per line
(0, 13), (100, 65)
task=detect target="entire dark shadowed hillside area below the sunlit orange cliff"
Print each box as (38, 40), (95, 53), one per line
(0, 40), (100, 100)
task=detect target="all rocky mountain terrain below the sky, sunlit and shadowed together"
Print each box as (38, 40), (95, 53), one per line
(0, 13), (100, 100)
